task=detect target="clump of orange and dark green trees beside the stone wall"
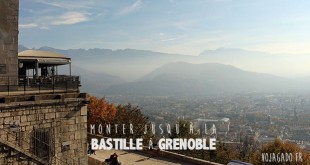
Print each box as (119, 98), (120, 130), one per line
(87, 99), (150, 142)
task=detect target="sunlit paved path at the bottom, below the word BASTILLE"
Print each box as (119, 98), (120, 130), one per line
(90, 150), (192, 165)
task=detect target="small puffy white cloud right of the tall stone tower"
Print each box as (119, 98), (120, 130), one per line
(51, 12), (89, 25)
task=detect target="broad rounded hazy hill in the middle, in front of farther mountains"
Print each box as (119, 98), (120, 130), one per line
(103, 62), (302, 97)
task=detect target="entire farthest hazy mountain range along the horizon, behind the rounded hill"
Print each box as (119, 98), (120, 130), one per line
(20, 46), (310, 81)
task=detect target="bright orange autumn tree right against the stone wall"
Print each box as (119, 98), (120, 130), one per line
(87, 96), (117, 124)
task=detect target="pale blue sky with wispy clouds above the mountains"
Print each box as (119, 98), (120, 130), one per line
(19, 0), (310, 55)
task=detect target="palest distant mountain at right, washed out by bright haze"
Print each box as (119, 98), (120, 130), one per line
(199, 48), (310, 77)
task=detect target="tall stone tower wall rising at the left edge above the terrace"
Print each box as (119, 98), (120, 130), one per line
(0, 0), (19, 85)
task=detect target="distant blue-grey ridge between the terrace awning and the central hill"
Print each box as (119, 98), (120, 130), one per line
(34, 47), (191, 81)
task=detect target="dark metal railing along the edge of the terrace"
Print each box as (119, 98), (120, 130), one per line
(0, 75), (80, 95)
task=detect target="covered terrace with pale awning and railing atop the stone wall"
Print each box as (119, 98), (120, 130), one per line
(0, 50), (80, 96)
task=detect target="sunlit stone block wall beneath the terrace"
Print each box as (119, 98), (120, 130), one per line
(0, 93), (88, 165)
